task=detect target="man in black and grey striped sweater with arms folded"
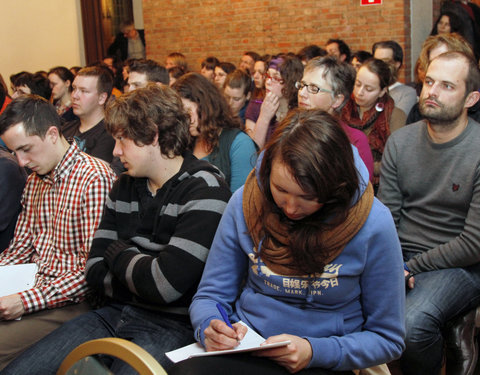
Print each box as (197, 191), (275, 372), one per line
(5, 85), (230, 374)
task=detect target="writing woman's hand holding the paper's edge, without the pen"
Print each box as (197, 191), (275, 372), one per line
(252, 334), (312, 374)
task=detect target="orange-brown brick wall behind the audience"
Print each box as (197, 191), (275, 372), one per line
(143, 0), (411, 79)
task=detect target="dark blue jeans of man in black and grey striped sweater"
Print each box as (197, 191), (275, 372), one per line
(2, 305), (194, 375)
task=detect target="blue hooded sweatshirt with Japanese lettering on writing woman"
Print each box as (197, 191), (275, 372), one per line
(190, 147), (405, 370)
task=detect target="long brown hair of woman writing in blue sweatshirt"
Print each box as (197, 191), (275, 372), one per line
(259, 109), (359, 273)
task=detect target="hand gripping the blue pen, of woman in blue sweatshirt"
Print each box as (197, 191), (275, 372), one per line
(204, 319), (248, 352)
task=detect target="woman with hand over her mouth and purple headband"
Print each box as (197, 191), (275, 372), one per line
(245, 55), (303, 148)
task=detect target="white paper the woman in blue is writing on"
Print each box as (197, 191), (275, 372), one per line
(165, 321), (290, 363)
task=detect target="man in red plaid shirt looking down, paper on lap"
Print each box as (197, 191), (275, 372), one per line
(0, 95), (115, 370)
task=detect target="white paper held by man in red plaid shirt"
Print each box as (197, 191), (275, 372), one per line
(0, 263), (38, 297)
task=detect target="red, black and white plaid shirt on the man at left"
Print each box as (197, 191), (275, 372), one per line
(0, 142), (116, 313)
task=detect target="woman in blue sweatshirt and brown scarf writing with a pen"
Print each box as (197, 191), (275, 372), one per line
(171, 111), (405, 375)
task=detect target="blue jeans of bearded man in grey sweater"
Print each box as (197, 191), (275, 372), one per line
(401, 253), (480, 375)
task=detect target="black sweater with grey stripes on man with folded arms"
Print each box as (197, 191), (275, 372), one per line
(86, 153), (230, 315)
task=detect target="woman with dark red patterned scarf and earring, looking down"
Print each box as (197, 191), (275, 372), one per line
(341, 59), (406, 187)
